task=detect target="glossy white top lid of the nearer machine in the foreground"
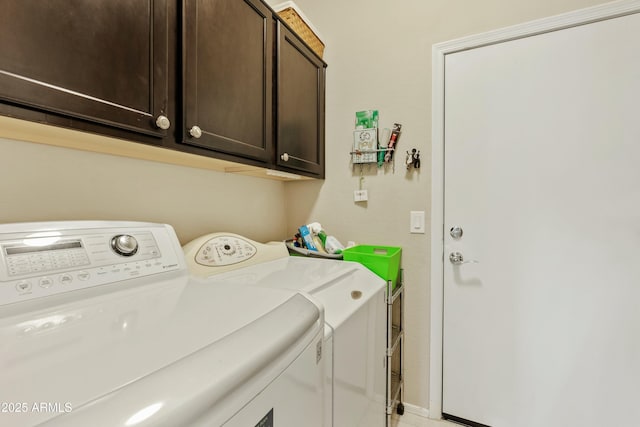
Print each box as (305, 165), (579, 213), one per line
(0, 279), (322, 426)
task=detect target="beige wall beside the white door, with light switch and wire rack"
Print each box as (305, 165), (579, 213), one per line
(273, 0), (603, 408)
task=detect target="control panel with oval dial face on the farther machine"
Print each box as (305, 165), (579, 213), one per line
(183, 233), (289, 277)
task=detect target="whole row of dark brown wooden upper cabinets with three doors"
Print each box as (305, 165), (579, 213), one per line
(0, 0), (326, 178)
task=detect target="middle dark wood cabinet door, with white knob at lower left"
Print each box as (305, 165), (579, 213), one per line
(182, 0), (273, 162)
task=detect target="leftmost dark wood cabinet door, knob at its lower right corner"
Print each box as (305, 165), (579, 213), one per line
(0, 0), (168, 136)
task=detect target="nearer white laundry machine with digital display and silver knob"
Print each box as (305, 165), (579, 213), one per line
(0, 221), (324, 427)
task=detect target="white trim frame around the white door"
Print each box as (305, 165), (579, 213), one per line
(429, 0), (640, 419)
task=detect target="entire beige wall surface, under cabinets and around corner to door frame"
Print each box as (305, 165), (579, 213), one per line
(0, 0), (601, 416)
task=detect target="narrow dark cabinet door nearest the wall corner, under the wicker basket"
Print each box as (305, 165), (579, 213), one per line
(276, 23), (325, 178)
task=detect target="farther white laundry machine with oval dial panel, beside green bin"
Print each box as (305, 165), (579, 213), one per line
(184, 233), (387, 427)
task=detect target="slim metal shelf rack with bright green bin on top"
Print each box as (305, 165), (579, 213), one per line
(343, 245), (404, 427)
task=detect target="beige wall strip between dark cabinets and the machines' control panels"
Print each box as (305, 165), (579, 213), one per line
(0, 139), (286, 244)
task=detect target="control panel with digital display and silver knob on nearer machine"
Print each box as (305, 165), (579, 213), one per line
(0, 221), (184, 305)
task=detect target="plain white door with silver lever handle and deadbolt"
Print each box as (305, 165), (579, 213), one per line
(442, 10), (640, 427)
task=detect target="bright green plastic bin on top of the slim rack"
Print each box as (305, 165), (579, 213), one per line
(342, 245), (402, 289)
